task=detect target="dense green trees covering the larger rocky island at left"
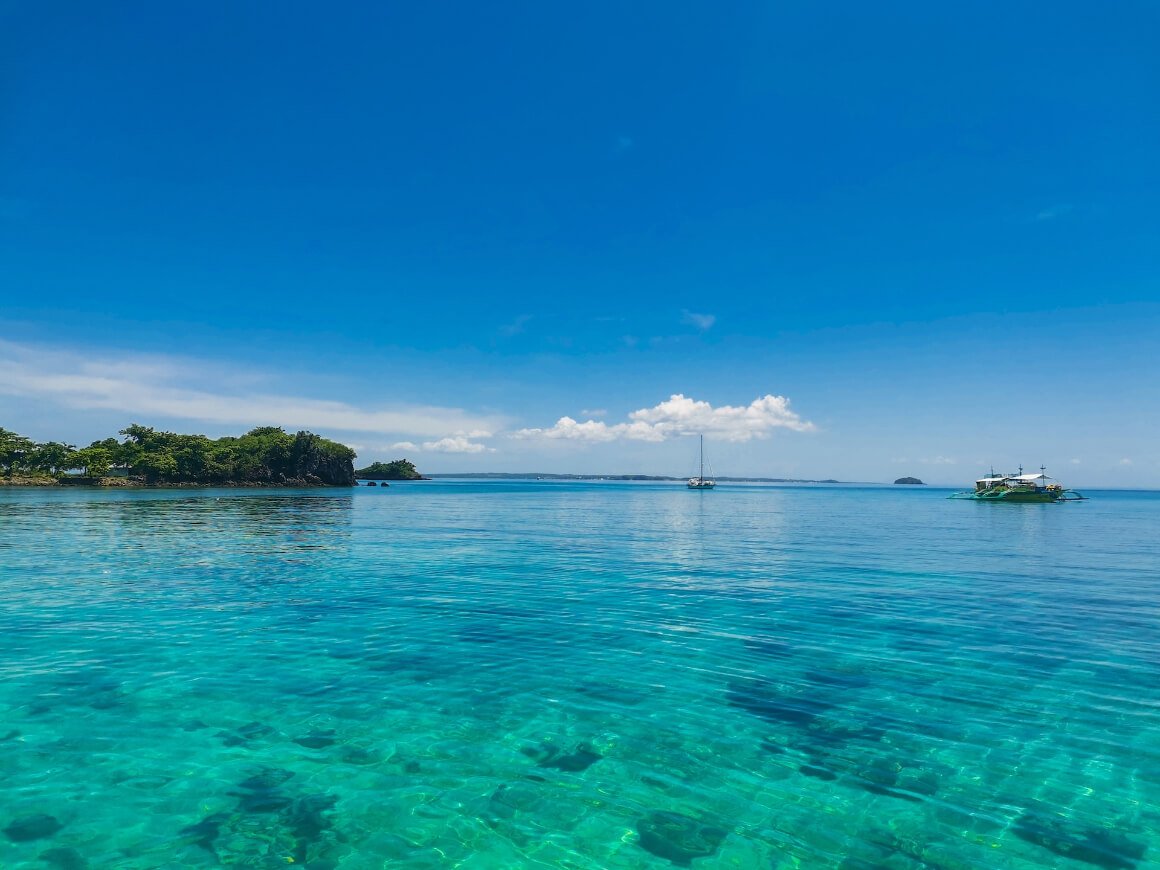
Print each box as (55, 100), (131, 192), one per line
(0, 423), (355, 485)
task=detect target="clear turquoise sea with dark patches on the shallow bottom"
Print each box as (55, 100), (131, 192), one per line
(0, 480), (1160, 870)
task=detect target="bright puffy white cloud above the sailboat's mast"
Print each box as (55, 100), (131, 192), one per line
(513, 393), (815, 443)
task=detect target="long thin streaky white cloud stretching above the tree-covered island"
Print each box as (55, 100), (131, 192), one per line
(0, 340), (505, 438)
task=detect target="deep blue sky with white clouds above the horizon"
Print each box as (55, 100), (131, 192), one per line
(0, 2), (1160, 486)
